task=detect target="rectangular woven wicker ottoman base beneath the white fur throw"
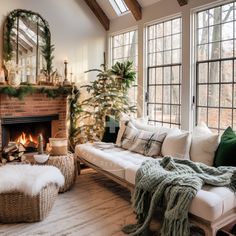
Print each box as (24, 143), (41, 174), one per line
(0, 184), (58, 223)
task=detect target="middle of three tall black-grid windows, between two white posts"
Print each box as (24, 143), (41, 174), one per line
(146, 17), (182, 127)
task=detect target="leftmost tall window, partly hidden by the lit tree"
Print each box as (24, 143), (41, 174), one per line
(111, 30), (138, 105)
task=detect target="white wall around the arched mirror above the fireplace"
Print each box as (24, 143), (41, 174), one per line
(0, 0), (106, 84)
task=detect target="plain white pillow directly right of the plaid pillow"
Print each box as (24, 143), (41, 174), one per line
(161, 129), (191, 159)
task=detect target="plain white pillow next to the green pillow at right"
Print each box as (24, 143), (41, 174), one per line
(190, 123), (219, 166)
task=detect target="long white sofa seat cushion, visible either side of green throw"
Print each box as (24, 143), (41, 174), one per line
(76, 144), (236, 221)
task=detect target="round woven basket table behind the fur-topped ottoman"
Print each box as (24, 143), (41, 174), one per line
(45, 153), (77, 193)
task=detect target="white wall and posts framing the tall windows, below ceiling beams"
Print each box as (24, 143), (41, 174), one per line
(109, 0), (222, 130)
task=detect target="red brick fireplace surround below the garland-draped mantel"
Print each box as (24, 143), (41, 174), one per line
(0, 93), (68, 149)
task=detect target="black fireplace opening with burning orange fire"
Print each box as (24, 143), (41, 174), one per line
(1, 114), (59, 152)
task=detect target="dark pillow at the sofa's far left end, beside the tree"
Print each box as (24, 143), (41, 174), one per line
(102, 116), (119, 143)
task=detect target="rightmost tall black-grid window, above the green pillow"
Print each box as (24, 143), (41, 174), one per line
(196, 2), (236, 132)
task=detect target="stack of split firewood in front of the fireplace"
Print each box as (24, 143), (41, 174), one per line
(2, 142), (26, 163)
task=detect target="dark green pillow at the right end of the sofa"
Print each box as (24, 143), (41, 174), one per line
(214, 127), (236, 167)
